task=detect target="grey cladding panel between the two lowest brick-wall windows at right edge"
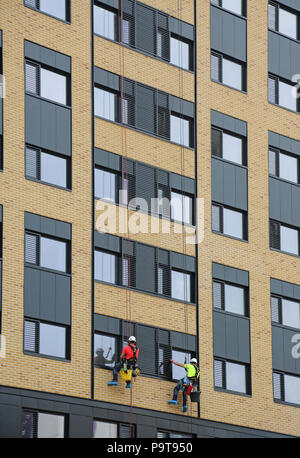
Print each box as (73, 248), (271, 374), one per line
(272, 325), (300, 375)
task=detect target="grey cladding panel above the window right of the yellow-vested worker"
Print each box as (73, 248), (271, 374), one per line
(213, 311), (250, 363)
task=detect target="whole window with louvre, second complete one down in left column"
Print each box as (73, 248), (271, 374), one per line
(25, 146), (71, 189)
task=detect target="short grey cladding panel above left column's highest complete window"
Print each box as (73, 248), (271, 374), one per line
(25, 40), (71, 73)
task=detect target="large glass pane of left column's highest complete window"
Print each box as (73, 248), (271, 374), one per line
(41, 68), (67, 105)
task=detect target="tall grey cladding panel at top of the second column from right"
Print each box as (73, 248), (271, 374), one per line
(210, 5), (247, 62)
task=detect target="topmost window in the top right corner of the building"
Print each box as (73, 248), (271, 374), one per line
(269, 2), (299, 40)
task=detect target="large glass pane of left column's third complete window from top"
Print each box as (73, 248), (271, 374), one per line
(40, 237), (67, 272)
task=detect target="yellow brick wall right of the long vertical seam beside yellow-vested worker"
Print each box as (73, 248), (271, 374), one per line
(197, 1), (300, 435)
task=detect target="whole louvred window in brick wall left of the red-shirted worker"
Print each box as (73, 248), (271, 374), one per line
(24, 319), (70, 359)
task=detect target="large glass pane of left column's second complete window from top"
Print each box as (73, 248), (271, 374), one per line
(41, 152), (67, 188)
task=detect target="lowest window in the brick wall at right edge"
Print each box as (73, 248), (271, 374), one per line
(273, 372), (300, 405)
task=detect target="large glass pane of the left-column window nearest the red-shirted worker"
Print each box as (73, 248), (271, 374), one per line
(39, 323), (66, 358)
